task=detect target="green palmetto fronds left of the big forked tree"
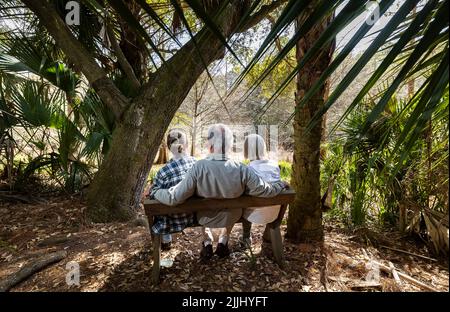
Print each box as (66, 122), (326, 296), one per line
(0, 29), (114, 192)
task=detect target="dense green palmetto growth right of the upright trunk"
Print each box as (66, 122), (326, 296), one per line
(322, 92), (448, 253)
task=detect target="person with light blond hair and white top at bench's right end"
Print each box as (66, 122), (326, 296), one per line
(241, 134), (281, 246)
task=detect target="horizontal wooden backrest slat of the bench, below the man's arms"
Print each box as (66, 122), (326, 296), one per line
(144, 190), (295, 216)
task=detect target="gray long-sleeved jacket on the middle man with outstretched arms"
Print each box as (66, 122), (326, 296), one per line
(154, 154), (285, 206)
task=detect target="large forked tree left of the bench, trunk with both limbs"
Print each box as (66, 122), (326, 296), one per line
(22, 0), (287, 222)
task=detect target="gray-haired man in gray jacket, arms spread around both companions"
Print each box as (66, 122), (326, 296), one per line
(153, 124), (286, 260)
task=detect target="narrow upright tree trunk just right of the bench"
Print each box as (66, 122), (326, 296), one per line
(286, 3), (333, 242)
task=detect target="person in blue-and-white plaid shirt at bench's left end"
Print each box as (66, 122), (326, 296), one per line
(149, 129), (196, 250)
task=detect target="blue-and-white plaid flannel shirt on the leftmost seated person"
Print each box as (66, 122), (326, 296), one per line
(149, 156), (196, 234)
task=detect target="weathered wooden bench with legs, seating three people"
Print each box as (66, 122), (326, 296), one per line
(144, 190), (295, 284)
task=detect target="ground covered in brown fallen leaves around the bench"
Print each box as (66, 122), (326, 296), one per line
(0, 197), (449, 292)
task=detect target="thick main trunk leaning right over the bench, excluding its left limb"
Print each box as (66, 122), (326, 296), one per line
(87, 31), (224, 222)
